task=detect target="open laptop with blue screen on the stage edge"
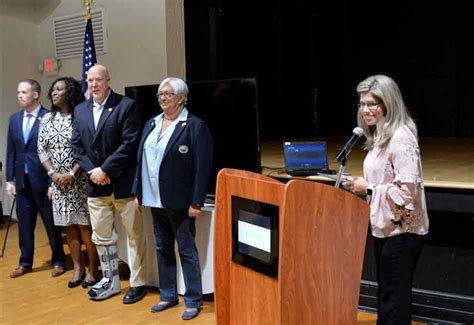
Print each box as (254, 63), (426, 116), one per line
(283, 141), (335, 176)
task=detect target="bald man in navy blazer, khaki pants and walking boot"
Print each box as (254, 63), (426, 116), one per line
(72, 65), (146, 304)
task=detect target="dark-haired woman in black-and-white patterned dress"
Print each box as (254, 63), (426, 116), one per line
(38, 77), (99, 288)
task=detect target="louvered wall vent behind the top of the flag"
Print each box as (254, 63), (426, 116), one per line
(53, 8), (107, 59)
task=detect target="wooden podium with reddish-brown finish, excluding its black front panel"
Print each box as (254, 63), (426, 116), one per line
(214, 169), (369, 325)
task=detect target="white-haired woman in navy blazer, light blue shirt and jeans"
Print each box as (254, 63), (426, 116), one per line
(134, 78), (213, 320)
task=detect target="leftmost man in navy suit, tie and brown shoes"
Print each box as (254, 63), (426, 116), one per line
(6, 79), (65, 278)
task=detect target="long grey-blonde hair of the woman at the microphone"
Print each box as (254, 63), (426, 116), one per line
(357, 75), (417, 150)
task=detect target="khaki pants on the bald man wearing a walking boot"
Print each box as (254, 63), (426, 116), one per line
(87, 194), (146, 287)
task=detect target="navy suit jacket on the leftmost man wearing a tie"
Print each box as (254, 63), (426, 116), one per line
(7, 107), (50, 192)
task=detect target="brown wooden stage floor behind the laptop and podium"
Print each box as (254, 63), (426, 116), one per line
(261, 137), (474, 190)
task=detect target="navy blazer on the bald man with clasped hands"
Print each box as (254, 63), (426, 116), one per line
(71, 91), (140, 199)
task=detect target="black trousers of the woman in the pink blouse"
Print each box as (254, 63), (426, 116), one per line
(374, 233), (423, 325)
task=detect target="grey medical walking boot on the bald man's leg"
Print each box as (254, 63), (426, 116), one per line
(87, 245), (121, 300)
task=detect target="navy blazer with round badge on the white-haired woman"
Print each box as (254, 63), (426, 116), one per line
(133, 114), (213, 209)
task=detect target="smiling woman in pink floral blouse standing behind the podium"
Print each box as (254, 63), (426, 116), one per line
(344, 75), (429, 325)
